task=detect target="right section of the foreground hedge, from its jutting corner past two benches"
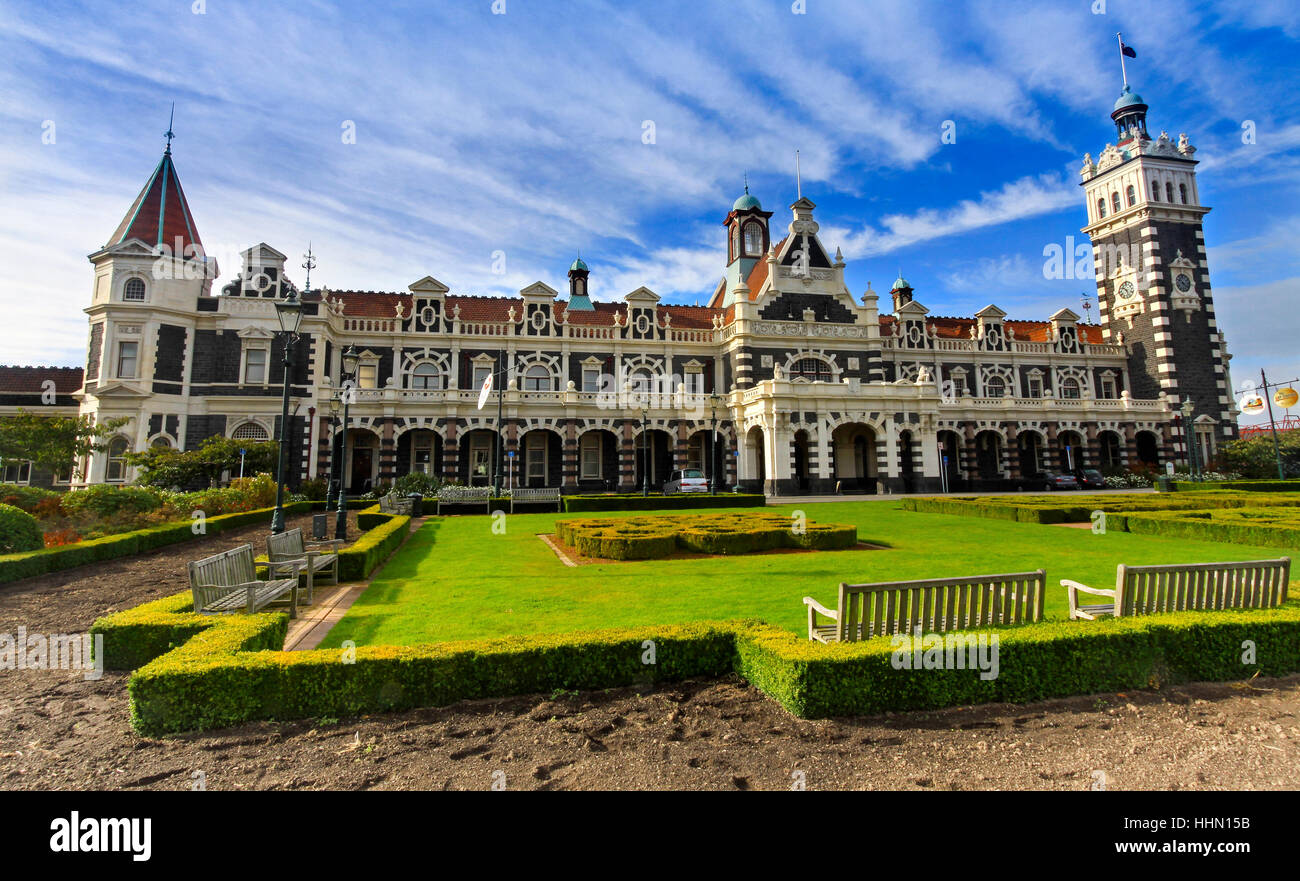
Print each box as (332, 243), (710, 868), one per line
(737, 602), (1300, 719)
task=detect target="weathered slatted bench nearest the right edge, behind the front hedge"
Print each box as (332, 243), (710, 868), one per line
(1061, 556), (1291, 621)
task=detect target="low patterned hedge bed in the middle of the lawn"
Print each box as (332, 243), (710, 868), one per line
(555, 513), (858, 560)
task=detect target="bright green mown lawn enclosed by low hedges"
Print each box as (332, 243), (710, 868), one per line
(322, 500), (1296, 647)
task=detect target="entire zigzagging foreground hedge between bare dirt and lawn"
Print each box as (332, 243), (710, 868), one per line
(94, 595), (1300, 735)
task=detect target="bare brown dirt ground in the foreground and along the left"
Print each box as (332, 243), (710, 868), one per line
(0, 518), (1300, 790)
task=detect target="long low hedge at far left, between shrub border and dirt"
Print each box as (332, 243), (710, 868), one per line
(0, 504), (311, 583)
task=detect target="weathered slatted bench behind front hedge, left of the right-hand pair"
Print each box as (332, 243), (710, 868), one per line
(803, 569), (1047, 643)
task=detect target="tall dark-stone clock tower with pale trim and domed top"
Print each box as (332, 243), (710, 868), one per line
(1080, 83), (1236, 464)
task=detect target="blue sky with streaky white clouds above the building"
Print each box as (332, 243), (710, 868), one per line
(0, 0), (1300, 421)
